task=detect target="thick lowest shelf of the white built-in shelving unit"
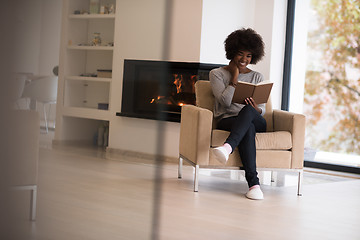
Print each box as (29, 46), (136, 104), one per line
(63, 107), (110, 121)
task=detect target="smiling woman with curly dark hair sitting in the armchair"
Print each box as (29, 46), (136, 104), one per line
(210, 28), (266, 199)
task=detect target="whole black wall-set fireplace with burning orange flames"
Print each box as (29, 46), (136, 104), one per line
(117, 60), (223, 122)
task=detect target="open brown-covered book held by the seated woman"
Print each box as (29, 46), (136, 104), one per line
(232, 81), (273, 104)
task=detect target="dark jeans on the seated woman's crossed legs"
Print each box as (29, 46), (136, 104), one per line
(217, 105), (266, 187)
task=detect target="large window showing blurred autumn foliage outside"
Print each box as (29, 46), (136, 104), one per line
(289, 0), (360, 173)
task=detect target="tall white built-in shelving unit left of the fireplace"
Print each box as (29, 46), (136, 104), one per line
(56, 0), (116, 142)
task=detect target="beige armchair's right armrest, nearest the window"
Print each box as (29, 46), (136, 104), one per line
(273, 110), (305, 169)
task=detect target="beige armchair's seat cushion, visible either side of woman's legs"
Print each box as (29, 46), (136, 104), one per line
(211, 129), (292, 150)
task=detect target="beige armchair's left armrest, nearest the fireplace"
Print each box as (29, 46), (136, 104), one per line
(179, 105), (213, 165)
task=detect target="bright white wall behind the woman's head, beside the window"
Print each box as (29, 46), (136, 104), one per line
(200, 0), (286, 109)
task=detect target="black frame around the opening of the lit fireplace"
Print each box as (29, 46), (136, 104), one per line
(116, 59), (224, 122)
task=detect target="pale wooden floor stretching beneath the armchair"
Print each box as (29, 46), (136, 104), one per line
(4, 134), (360, 240)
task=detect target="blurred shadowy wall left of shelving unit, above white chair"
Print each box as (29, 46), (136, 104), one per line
(14, 0), (62, 75)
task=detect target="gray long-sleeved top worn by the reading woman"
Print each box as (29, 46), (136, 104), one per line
(209, 67), (265, 121)
